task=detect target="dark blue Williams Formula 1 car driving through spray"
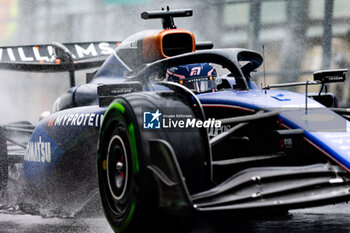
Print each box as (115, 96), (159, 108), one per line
(0, 9), (350, 232)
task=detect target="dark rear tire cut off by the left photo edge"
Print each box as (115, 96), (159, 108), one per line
(0, 128), (8, 199)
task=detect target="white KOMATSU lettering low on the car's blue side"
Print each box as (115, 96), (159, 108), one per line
(24, 136), (51, 163)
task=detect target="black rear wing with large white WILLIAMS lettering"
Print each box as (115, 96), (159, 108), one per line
(0, 41), (120, 87)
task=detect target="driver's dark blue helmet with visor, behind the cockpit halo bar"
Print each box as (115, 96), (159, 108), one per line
(165, 63), (216, 93)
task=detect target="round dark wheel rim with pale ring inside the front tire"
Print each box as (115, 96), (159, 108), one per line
(106, 135), (128, 202)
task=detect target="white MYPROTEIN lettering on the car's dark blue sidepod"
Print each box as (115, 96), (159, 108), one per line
(48, 113), (103, 127)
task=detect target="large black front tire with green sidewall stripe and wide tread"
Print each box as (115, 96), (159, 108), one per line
(97, 92), (211, 232)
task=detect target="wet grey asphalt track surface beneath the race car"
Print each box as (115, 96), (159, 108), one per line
(0, 204), (350, 233)
